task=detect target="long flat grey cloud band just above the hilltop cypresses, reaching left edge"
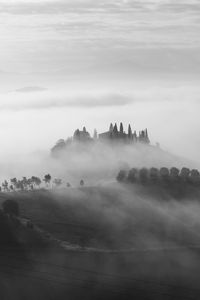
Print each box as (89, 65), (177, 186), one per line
(0, 91), (132, 111)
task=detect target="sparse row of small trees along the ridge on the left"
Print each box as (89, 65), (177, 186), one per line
(0, 174), (84, 192)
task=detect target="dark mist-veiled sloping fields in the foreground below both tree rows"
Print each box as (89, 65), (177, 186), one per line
(0, 184), (200, 300)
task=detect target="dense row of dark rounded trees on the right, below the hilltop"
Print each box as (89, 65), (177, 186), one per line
(116, 167), (200, 186)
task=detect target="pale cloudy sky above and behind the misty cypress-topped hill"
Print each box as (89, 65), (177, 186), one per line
(0, 0), (200, 169)
